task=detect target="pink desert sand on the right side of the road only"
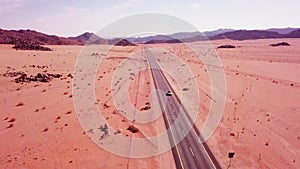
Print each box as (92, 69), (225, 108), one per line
(144, 39), (300, 168)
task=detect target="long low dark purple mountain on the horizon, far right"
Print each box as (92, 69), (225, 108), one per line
(210, 30), (285, 40)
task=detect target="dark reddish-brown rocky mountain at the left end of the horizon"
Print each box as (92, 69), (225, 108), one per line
(0, 29), (82, 45)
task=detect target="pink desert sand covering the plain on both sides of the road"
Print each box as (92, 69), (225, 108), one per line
(0, 39), (300, 168)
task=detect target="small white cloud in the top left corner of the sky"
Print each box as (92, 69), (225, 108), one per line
(0, 0), (26, 14)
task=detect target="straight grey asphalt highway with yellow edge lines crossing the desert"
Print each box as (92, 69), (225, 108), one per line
(146, 48), (221, 169)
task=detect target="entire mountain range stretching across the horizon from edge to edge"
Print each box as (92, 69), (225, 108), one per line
(0, 28), (300, 46)
